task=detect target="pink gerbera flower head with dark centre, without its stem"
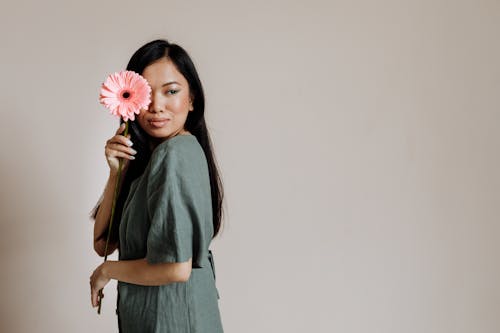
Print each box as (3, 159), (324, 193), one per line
(99, 71), (151, 121)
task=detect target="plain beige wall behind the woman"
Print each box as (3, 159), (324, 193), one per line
(0, 0), (500, 333)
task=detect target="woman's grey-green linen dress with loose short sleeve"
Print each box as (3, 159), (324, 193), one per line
(116, 134), (223, 333)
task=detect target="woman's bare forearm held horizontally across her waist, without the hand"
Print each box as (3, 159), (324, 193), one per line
(102, 258), (191, 286)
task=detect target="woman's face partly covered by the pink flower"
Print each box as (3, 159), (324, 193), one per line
(137, 58), (193, 141)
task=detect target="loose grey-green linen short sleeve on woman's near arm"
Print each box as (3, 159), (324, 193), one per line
(146, 143), (211, 267)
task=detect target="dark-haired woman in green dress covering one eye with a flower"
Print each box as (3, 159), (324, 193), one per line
(90, 40), (223, 333)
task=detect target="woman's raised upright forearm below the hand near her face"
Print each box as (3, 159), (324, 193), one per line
(94, 171), (118, 257)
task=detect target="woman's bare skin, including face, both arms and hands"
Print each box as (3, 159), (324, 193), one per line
(90, 58), (193, 307)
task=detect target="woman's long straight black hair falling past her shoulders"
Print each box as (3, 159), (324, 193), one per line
(90, 39), (224, 243)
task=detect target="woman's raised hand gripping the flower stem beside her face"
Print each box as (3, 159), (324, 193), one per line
(104, 123), (137, 172)
